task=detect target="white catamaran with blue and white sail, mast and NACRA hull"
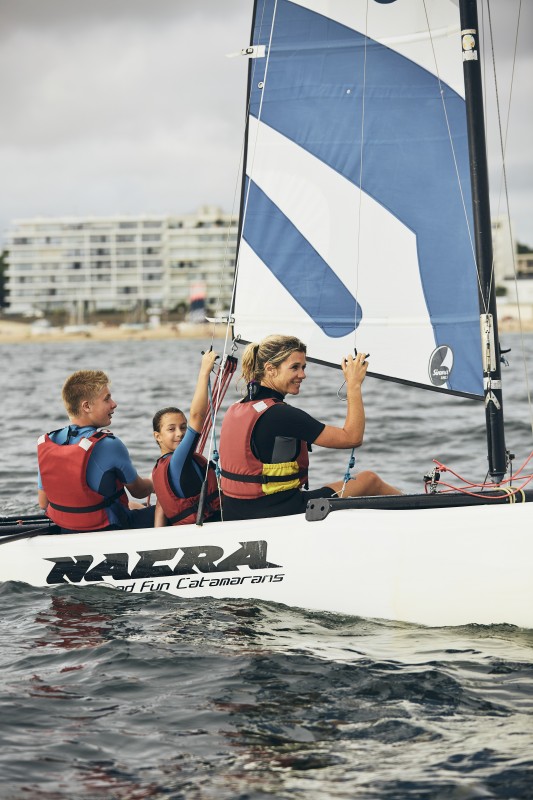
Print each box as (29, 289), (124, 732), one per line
(0, 0), (533, 627)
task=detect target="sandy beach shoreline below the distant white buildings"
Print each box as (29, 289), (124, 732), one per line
(0, 316), (533, 344)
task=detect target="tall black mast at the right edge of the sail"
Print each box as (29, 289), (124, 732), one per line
(459, 0), (507, 483)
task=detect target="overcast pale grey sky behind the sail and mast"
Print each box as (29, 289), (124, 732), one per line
(0, 0), (533, 246)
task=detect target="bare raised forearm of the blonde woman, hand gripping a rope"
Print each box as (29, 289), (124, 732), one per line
(314, 353), (368, 449)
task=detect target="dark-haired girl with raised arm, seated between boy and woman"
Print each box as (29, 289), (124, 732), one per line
(152, 350), (220, 528)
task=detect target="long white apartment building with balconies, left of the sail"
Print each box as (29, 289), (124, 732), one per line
(6, 206), (237, 314)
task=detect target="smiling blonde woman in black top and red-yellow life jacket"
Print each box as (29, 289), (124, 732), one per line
(220, 335), (401, 519)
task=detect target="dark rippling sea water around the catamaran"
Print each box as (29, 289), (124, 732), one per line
(0, 336), (533, 800)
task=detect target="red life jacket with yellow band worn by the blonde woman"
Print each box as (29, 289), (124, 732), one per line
(219, 397), (309, 500)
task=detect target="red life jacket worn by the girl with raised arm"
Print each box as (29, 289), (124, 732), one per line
(152, 453), (220, 525)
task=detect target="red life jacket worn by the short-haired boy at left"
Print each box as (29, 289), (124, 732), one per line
(37, 431), (128, 531)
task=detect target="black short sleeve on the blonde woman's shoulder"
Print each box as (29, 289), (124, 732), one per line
(252, 403), (326, 463)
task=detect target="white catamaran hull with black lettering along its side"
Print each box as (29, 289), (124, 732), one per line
(0, 503), (533, 628)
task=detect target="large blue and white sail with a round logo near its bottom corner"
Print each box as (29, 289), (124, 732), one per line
(234, 0), (482, 395)
